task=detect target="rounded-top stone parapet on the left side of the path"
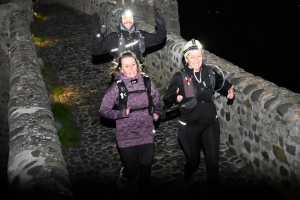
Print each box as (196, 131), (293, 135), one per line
(8, 11), (72, 199)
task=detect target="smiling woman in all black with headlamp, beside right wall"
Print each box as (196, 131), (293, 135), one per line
(163, 39), (234, 195)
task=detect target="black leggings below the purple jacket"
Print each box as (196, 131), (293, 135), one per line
(119, 143), (154, 187)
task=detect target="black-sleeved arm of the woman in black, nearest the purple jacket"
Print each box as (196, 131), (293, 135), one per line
(163, 72), (182, 107)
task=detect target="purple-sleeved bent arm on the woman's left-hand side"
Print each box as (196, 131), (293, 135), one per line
(99, 83), (128, 119)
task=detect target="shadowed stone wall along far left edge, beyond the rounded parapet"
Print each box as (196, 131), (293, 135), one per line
(0, 0), (32, 194)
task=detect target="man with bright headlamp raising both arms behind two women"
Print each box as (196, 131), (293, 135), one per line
(92, 9), (167, 64)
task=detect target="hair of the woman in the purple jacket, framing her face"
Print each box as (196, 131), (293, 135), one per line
(108, 51), (143, 76)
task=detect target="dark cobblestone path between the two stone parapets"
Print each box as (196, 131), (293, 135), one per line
(31, 4), (281, 200)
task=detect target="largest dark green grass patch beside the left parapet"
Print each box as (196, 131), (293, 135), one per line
(52, 103), (80, 147)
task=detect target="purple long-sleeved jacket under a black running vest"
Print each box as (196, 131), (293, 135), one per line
(100, 73), (161, 148)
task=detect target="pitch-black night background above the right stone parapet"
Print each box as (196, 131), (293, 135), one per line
(177, 0), (300, 93)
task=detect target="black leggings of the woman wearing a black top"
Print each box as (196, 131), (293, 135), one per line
(178, 120), (220, 187)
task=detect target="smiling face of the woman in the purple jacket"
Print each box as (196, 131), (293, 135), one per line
(120, 57), (138, 78)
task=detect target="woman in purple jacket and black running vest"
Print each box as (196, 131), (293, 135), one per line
(100, 51), (161, 194)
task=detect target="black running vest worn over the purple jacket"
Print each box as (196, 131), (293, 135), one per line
(116, 74), (154, 115)
